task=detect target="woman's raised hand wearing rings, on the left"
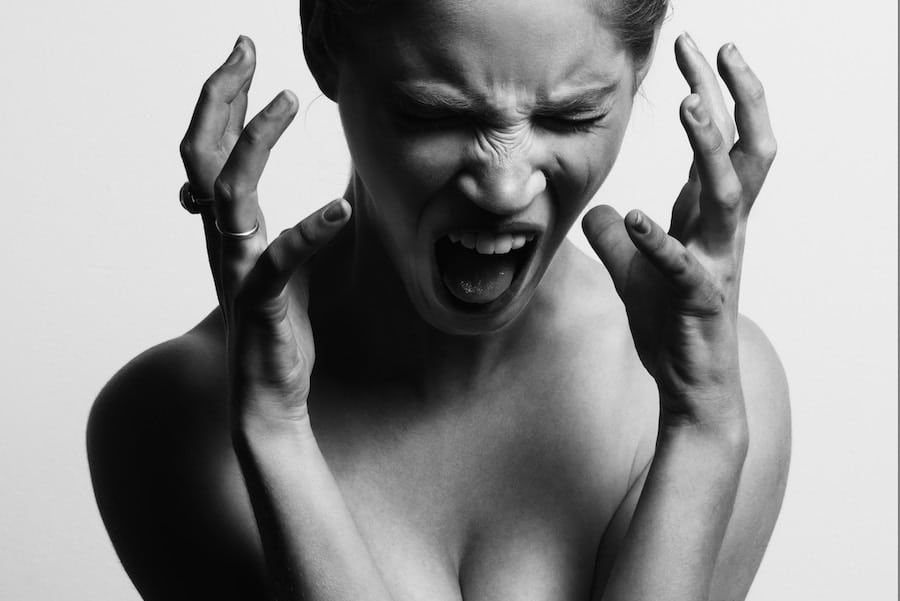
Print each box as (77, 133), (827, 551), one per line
(181, 36), (350, 432)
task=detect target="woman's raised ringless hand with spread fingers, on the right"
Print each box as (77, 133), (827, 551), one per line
(582, 34), (775, 428)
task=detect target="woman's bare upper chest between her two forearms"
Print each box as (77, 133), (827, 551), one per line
(296, 378), (634, 601)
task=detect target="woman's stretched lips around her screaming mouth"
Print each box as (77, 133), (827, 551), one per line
(431, 229), (543, 316)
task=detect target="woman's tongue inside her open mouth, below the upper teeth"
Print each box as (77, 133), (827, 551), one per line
(442, 244), (516, 304)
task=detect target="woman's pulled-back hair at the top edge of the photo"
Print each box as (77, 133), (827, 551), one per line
(300, 0), (669, 69)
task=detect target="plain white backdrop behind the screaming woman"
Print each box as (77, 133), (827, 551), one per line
(0, 0), (897, 601)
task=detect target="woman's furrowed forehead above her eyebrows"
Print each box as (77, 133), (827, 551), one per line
(352, 0), (633, 97)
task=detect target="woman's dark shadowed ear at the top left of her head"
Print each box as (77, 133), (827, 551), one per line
(300, 0), (338, 102)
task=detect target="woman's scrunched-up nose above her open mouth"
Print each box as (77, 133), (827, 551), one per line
(458, 149), (547, 215)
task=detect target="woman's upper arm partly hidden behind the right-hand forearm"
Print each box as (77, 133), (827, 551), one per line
(595, 317), (791, 601)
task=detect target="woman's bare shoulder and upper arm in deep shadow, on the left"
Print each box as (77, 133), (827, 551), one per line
(87, 318), (261, 600)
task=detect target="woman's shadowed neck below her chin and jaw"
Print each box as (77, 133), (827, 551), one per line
(310, 171), (568, 397)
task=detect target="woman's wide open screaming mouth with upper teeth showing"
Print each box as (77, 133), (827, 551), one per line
(435, 231), (537, 311)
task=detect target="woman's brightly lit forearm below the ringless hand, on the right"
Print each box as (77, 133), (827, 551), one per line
(601, 408), (747, 601)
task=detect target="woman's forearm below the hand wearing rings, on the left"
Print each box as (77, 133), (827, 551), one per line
(233, 423), (390, 601)
